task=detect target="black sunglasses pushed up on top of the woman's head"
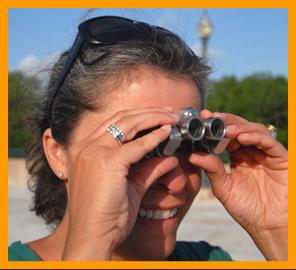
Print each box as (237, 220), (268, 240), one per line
(48, 16), (174, 118)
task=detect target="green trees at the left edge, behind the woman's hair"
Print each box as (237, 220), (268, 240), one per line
(8, 71), (40, 156)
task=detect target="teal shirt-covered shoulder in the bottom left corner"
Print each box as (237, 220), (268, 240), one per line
(8, 241), (41, 261)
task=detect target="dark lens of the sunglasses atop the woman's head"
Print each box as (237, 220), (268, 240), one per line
(87, 18), (143, 43)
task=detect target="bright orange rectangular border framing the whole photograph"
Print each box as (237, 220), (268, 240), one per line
(0, 0), (296, 269)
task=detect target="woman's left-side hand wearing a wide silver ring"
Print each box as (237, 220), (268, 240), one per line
(63, 108), (178, 260)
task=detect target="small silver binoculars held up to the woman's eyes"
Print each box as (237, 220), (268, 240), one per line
(142, 108), (229, 158)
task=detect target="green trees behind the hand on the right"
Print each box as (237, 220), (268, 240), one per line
(208, 73), (288, 147)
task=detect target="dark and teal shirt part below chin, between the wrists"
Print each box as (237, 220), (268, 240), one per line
(168, 241), (232, 261)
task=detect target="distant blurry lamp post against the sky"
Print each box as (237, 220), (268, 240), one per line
(198, 10), (213, 62)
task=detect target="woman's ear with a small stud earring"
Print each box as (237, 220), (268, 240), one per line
(42, 128), (67, 180)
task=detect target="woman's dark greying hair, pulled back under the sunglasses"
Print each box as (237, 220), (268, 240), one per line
(26, 16), (210, 226)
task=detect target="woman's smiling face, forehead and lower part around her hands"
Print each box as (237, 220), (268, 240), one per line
(67, 67), (201, 260)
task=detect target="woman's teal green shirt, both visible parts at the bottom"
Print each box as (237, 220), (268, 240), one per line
(8, 241), (232, 261)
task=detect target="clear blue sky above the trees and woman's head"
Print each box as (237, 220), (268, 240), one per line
(8, 8), (288, 78)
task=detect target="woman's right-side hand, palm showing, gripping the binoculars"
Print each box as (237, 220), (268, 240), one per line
(190, 110), (288, 260)
